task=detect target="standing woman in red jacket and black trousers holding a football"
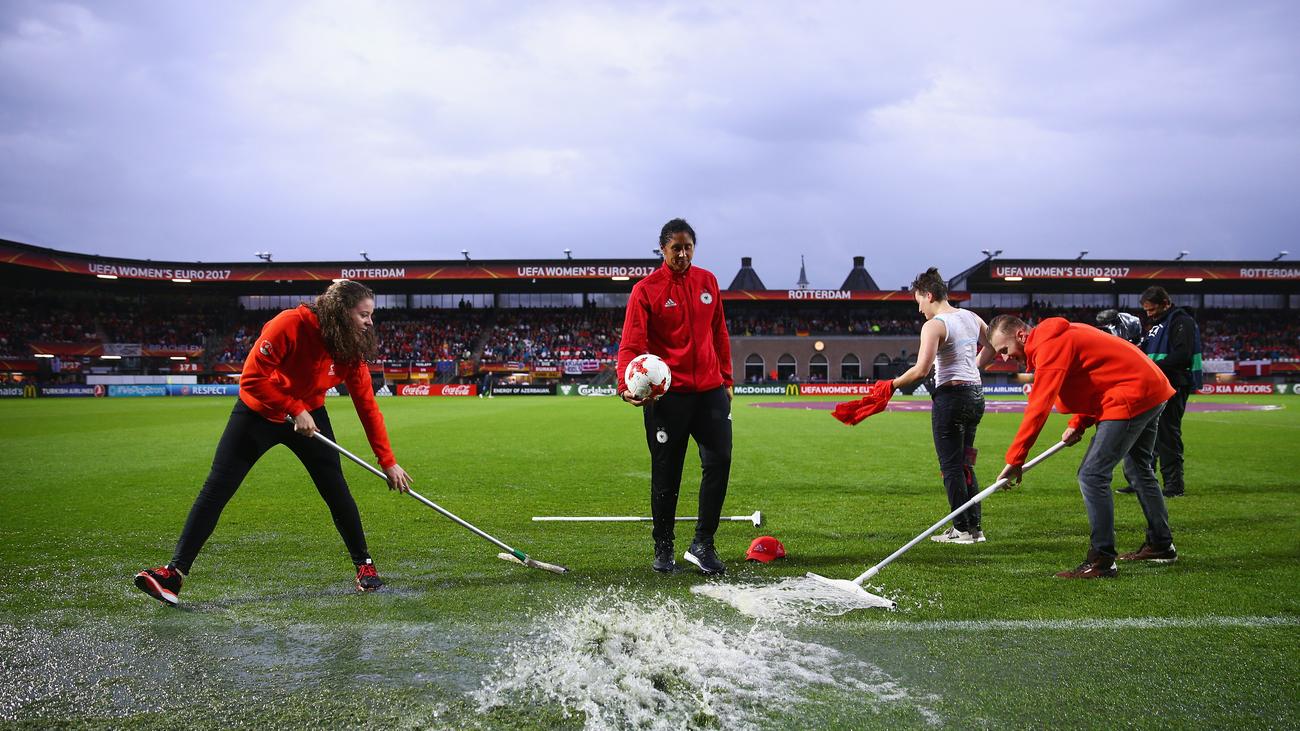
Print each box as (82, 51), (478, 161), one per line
(619, 219), (732, 574)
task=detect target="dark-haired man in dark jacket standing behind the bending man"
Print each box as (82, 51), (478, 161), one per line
(1123, 286), (1201, 497)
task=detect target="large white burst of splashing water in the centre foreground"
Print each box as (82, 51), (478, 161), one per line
(475, 597), (939, 730)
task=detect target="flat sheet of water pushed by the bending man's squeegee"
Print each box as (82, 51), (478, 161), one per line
(690, 576), (892, 624)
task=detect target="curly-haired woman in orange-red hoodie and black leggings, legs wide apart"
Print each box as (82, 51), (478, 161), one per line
(135, 280), (411, 605)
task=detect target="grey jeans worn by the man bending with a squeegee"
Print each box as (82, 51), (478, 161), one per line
(1079, 403), (1174, 558)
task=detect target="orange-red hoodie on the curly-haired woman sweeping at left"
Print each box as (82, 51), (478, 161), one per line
(239, 304), (398, 467)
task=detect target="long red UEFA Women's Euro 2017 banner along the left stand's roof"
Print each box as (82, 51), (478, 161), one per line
(0, 241), (659, 282)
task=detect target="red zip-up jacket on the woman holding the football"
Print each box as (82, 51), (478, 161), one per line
(619, 264), (732, 394)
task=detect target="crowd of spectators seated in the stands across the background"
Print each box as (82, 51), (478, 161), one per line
(0, 293), (1300, 363)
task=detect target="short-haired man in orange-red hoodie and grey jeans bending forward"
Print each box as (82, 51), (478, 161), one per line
(988, 315), (1178, 579)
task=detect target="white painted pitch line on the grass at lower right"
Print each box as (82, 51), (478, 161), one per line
(858, 615), (1300, 632)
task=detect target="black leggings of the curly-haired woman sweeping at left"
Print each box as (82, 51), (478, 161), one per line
(172, 401), (371, 574)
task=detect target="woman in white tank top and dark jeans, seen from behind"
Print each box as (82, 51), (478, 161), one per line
(894, 267), (996, 544)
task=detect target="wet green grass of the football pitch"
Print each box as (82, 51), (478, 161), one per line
(0, 397), (1300, 728)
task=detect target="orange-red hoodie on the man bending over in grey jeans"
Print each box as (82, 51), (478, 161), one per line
(1006, 317), (1174, 464)
